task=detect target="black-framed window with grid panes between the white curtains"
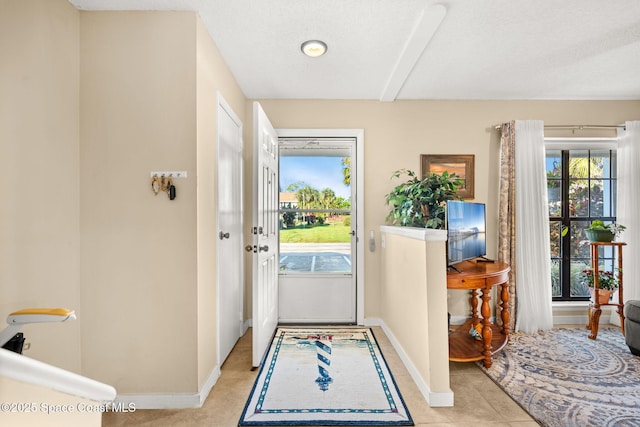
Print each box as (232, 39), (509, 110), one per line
(546, 145), (616, 301)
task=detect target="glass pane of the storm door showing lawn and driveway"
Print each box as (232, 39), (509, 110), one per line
(280, 153), (352, 274)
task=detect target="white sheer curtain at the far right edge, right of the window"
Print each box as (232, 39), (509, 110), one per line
(612, 121), (640, 302)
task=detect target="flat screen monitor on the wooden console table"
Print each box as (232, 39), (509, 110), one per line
(446, 200), (487, 265)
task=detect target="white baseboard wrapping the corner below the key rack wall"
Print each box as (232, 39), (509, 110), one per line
(115, 366), (220, 409)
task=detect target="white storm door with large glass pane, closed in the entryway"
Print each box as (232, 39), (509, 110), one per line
(279, 137), (358, 324)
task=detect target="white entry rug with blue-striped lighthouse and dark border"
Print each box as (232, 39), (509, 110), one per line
(239, 328), (413, 426)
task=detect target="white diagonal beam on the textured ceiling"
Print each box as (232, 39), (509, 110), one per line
(380, 4), (447, 102)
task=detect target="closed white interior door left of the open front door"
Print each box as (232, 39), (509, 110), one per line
(217, 94), (244, 365)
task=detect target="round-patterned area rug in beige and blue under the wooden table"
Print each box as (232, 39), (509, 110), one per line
(479, 328), (640, 427)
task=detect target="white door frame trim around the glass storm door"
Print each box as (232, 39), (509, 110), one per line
(276, 128), (366, 325)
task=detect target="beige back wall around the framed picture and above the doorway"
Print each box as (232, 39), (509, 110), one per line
(252, 100), (640, 317)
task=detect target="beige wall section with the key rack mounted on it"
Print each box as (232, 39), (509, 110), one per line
(80, 12), (198, 394)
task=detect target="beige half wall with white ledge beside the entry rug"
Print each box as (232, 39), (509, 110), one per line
(380, 226), (453, 406)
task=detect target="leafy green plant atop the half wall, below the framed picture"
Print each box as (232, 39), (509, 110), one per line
(386, 169), (463, 229)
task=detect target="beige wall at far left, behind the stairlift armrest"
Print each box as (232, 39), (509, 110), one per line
(0, 0), (83, 372)
